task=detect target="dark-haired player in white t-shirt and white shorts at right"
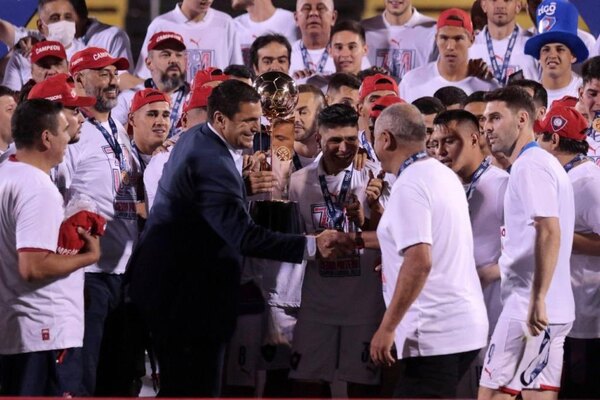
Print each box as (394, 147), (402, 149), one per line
(478, 86), (575, 399)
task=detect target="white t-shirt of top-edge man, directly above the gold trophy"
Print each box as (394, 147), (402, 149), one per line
(234, 8), (300, 66)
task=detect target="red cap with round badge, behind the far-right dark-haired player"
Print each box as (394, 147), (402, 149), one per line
(534, 106), (588, 141)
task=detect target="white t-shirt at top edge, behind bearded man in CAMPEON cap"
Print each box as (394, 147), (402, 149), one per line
(135, 4), (243, 82)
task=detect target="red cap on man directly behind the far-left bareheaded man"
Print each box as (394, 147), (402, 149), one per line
(27, 74), (96, 107)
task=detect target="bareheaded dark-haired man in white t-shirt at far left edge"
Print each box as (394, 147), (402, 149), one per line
(0, 99), (100, 397)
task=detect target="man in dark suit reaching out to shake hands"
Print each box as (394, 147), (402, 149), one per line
(129, 80), (354, 397)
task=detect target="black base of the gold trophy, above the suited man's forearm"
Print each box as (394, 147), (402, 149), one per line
(250, 200), (303, 234)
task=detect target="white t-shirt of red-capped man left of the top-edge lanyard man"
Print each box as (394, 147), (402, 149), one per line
(400, 61), (500, 103)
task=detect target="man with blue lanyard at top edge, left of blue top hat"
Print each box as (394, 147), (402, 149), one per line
(469, 0), (539, 85)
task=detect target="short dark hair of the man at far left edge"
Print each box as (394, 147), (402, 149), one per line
(10, 99), (63, 149)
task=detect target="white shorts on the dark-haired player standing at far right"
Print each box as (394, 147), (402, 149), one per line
(479, 317), (573, 395)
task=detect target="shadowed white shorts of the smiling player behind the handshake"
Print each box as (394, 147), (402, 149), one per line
(290, 320), (381, 385)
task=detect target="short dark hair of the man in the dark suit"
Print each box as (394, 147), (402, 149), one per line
(208, 79), (260, 122)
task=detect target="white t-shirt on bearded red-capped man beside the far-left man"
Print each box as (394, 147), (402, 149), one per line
(64, 115), (143, 274)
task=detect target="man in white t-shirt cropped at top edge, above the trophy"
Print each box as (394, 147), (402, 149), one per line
(231, 0), (298, 67)
